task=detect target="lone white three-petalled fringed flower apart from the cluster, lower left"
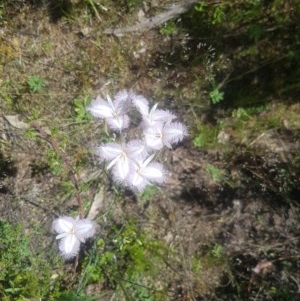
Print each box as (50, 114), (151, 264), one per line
(52, 216), (96, 259)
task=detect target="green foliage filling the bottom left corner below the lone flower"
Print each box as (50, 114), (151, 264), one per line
(0, 221), (97, 301)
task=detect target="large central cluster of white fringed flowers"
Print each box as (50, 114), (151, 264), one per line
(87, 90), (187, 191)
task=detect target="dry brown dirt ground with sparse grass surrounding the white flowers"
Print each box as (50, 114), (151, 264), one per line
(0, 1), (300, 301)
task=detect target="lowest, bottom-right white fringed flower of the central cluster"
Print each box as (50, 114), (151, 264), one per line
(127, 154), (165, 191)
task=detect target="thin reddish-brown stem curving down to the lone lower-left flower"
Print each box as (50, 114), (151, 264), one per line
(31, 122), (83, 219)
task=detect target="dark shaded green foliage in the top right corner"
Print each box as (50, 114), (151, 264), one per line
(189, 0), (300, 96)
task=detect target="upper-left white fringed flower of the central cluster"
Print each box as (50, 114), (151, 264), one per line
(87, 95), (130, 131)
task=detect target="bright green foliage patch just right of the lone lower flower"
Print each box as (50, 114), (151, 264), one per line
(78, 220), (166, 301)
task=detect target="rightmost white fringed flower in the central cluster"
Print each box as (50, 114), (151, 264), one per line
(144, 122), (187, 150)
